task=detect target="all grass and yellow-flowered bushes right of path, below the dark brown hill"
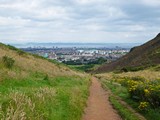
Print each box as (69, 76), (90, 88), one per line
(96, 65), (160, 120)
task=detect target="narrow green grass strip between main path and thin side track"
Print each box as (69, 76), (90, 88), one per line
(109, 96), (139, 120)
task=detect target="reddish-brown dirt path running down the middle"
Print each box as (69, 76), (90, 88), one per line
(82, 78), (121, 120)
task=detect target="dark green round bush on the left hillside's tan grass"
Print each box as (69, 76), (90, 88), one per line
(2, 55), (15, 69)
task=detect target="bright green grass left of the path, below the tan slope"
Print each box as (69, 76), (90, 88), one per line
(0, 74), (90, 120)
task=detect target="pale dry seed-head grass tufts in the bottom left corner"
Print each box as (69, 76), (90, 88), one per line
(0, 87), (56, 120)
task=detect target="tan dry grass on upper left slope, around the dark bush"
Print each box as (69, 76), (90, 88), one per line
(0, 47), (84, 80)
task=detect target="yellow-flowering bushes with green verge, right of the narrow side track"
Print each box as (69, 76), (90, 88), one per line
(102, 76), (160, 120)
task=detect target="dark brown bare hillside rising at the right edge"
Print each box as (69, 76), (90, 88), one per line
(94, 33), (160, 73)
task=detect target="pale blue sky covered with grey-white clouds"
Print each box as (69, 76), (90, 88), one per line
(0, 0), (160, 43)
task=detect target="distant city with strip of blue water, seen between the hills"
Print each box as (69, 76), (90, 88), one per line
(14, 43), (139, 65)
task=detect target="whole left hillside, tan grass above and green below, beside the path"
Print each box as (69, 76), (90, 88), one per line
(0, 44), (90, 120)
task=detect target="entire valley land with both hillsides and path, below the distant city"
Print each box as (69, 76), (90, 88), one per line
(0, 35), (160, 120)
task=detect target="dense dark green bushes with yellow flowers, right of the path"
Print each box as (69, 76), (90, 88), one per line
(117, 78), (160, 110)
